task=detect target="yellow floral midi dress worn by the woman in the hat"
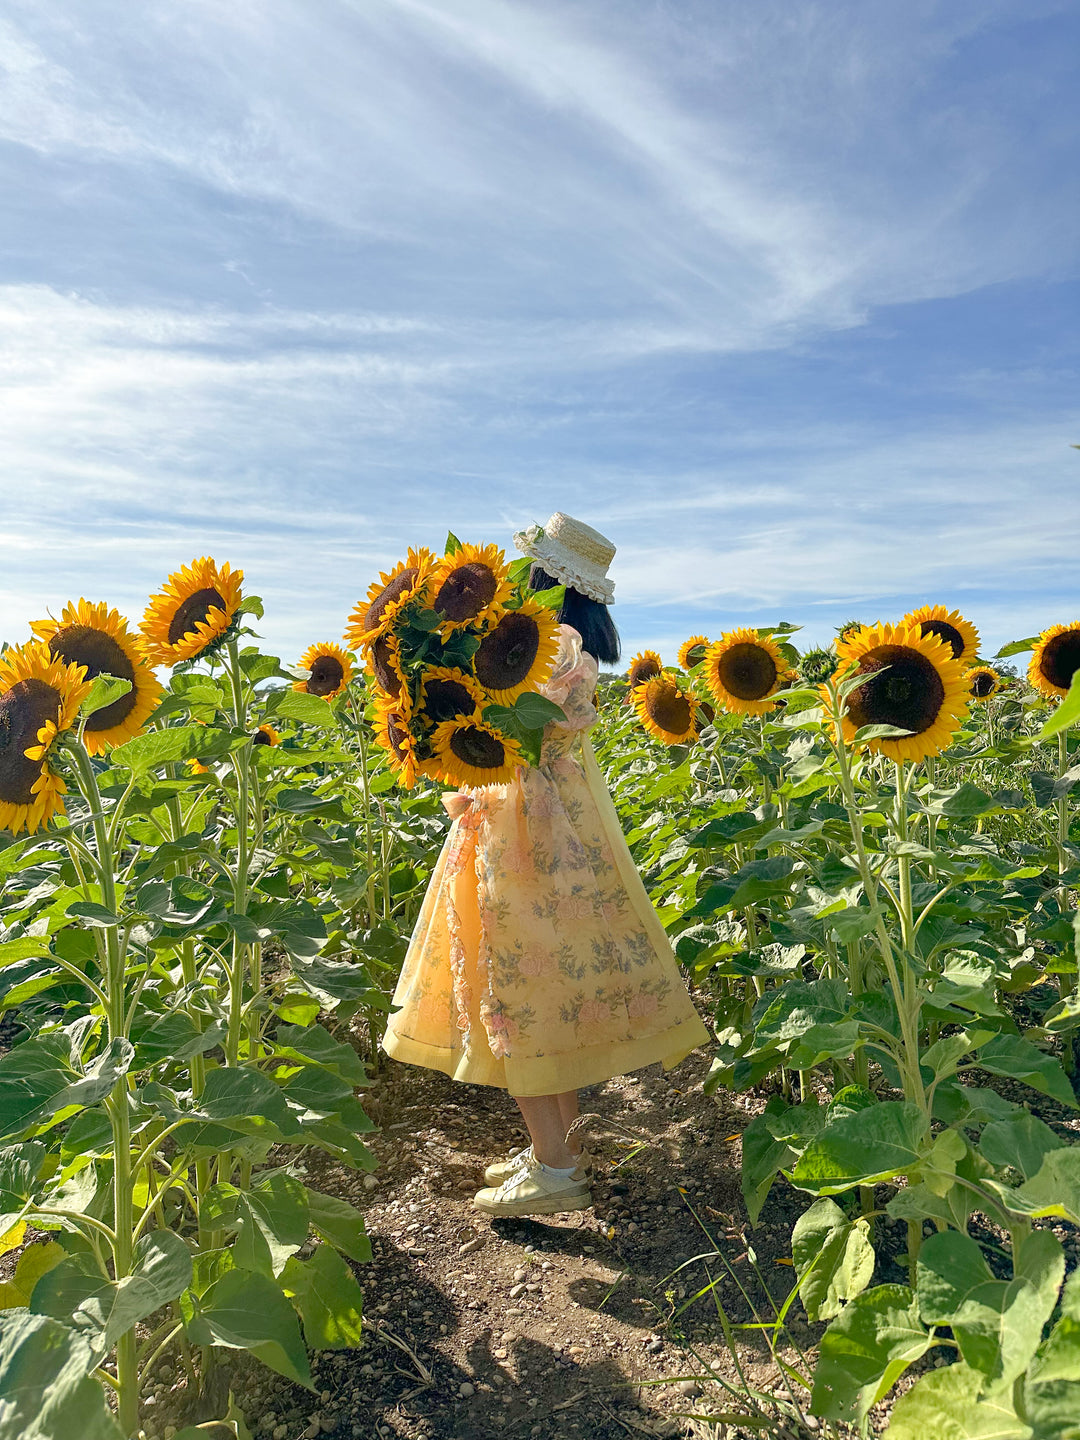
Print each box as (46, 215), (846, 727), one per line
(383, 625), (708, 1096)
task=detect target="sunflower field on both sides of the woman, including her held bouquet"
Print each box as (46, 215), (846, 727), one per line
(0, 536), (1080, 1440)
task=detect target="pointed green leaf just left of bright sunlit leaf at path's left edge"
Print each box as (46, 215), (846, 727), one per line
(186, 1270), (314, 1390)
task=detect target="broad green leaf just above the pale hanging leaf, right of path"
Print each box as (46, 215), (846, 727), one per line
(791, 1100), (929, 1195)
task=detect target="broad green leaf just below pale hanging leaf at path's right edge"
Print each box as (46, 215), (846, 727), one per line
(811, 1284), (933, 1422)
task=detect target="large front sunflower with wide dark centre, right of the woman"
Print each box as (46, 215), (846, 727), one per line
(837, 622), (968, 760)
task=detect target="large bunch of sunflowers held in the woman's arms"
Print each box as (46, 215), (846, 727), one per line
(346, 534), (563, 786)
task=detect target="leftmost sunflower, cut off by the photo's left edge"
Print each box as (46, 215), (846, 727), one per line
(0, 642), (91, 835)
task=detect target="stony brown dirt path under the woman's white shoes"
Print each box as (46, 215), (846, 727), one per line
(224, 1057), (809, 1440)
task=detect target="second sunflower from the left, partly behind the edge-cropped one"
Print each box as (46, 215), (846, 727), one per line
(30, 600), (161, 755)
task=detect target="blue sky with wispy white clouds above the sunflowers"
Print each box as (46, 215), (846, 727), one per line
(0, 0), (1080, 660)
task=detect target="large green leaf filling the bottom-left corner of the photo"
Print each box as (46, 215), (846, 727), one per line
(0, 1310), (124, 1440)
